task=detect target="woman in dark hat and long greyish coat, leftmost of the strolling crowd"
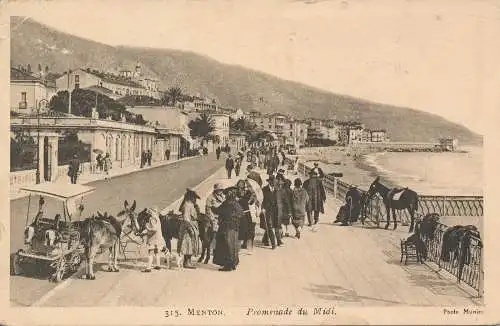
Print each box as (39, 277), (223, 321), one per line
(177, 189), (200, 269)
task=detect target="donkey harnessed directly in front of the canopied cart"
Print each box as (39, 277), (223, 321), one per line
(73, 212), (123, 280)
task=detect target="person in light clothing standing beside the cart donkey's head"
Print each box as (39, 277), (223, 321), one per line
(143, 206), (166, 273)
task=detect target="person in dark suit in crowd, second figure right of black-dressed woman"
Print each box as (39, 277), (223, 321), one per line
(260, 175), (283, 249)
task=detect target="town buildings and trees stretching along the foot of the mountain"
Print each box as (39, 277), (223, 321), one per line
(10, 62), (457, 188)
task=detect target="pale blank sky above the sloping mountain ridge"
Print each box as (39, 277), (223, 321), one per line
(3, 0), (500, 134)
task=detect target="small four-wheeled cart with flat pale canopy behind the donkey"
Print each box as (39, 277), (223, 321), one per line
(13, 183), (94, 282)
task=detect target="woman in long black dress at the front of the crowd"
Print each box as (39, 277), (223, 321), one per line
(212, 187), (244, 271)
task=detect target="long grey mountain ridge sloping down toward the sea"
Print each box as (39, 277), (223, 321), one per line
(11, 17), (482, 144)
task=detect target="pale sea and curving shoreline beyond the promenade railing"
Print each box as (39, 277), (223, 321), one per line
(308, 146), (484, 230)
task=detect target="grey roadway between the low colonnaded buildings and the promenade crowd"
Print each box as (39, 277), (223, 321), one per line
(10, 154), (224, 305)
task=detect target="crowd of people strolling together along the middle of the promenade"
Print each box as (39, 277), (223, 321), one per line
(141, 146), (326, 271)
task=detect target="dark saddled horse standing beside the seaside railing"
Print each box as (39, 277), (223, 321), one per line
(368, 177), (418, 232)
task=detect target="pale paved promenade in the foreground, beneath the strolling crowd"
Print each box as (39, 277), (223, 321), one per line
(29, 163), (478, 308)
